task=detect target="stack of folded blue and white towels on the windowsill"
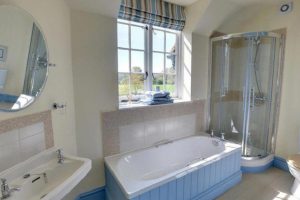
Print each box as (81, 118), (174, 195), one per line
(141, 91), (174, 105)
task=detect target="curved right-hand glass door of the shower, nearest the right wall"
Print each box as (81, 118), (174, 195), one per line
(243, 37), (280, 157)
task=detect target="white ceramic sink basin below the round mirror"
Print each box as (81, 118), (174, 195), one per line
(0, 148), (91, 200)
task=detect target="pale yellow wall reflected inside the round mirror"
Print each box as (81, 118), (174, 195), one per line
(0, 6), (33, 96)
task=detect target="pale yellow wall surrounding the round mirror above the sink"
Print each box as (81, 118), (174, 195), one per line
(0, 0), (77, 154)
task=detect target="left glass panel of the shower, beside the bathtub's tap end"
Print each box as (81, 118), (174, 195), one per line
(210, 38), (252, 143)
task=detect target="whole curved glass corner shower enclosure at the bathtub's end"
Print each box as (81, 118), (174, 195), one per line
(210, 32), (282, 158)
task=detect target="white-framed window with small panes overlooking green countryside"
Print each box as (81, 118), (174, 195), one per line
(118, 20), (180, 104)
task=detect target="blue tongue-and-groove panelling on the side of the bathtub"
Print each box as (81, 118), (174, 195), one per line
(105, 152), (242, 200)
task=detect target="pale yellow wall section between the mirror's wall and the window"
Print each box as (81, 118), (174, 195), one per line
(69, 11), (118, 199)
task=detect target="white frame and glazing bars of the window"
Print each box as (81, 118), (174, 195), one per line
(117, 19), (182, 104)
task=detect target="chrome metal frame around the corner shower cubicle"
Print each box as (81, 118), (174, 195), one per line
(207, 30), (286, 160)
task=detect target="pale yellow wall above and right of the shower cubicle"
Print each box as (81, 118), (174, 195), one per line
(219, 1), (300, 158)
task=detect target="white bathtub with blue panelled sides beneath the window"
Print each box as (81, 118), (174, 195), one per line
(105, 136), (241, 200)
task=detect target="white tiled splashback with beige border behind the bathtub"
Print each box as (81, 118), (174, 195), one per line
(102, 100), (206, 156)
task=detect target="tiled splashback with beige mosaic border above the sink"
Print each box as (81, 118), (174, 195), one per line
(0, 111), (53, 171)
